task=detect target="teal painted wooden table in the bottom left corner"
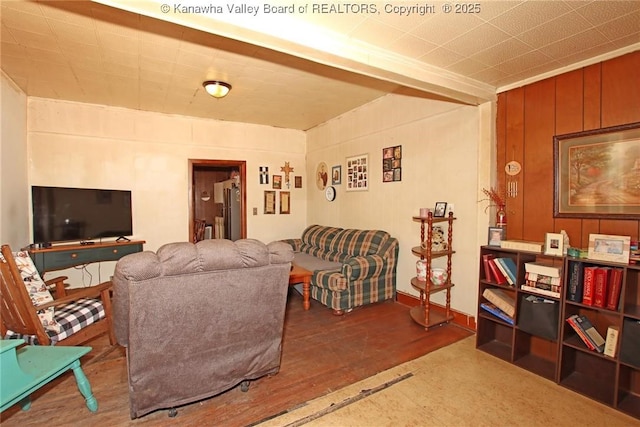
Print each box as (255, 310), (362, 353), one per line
(0, 340), (98, 412)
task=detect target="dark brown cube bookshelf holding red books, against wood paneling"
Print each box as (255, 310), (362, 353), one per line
(476, 246), (640, 419)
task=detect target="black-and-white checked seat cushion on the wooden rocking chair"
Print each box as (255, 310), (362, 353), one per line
(5, 298), (105, 345)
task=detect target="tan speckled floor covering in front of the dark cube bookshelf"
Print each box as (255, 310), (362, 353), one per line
(259, 336), (640, 427)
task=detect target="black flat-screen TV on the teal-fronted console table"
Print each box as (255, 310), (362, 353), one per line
(31, 186), (133, 243)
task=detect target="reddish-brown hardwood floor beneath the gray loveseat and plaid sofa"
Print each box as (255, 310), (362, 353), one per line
(0, 289), (473, 427)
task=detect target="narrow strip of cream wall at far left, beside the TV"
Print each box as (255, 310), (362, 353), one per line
(0, 73), (30, 250)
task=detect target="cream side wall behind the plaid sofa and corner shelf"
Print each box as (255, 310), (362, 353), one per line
(307, 95), (491, 315)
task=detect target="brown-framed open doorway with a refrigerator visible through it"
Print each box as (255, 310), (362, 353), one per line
(189, 159), (247, 242)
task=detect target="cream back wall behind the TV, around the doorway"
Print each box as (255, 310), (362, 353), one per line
(27, 98), (307, 285)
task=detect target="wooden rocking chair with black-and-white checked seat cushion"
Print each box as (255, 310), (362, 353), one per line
(0, 245), (116, 345)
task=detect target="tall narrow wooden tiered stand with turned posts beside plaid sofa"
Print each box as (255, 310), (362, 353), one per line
(409, 212), (456, 330)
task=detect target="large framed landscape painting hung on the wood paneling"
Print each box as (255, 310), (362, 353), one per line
(553, 123), (640, 219)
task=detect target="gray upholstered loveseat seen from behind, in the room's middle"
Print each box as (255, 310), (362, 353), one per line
(113, 239), (293, 419)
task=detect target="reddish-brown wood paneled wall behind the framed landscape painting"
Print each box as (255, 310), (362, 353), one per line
(497, 51), (640, 248)
